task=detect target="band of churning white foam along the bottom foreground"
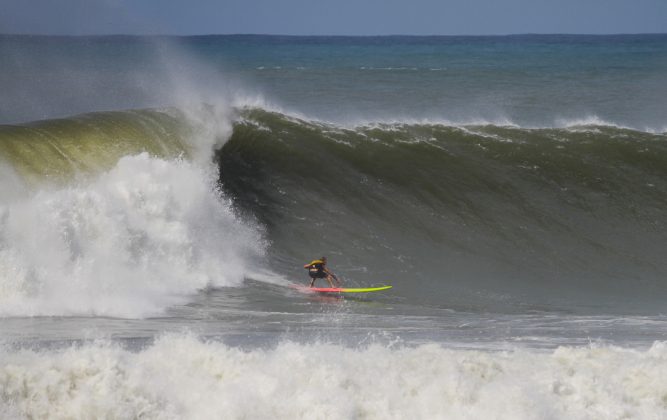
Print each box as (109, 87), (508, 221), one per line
(0, 335), (667, 420)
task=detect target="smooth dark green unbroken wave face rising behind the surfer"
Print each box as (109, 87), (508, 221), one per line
(222, 109), (667, 314)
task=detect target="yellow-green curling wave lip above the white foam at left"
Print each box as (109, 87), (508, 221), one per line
(0, 109), (192, 184)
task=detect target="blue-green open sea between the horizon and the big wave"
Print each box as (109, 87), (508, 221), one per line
(0, 35), (667, 131)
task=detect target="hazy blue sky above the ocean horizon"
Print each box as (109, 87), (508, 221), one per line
(0, 0), (667, 35)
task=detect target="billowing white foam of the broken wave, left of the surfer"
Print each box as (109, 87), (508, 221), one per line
(0, 153), (263, 317)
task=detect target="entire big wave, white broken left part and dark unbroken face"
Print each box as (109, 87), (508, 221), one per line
(0, 107), (667, 317)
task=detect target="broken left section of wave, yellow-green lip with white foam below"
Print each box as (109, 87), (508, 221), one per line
(0, 110), (263, 318)
